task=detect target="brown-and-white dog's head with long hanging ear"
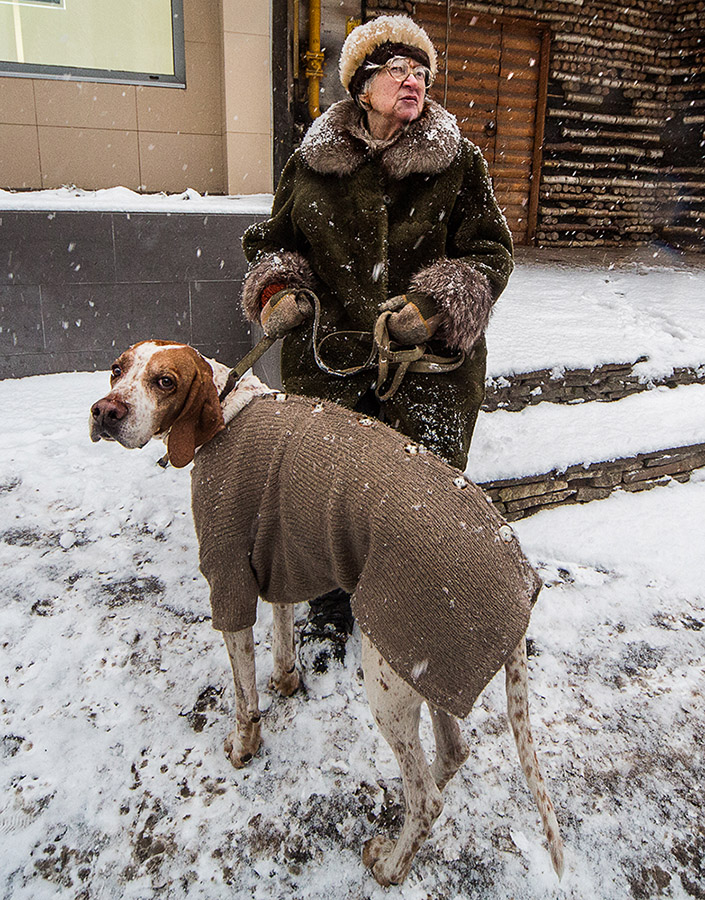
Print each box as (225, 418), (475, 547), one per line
(90, 341), (225, 468)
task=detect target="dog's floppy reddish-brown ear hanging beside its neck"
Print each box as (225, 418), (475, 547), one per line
(166, 356), (225, 469)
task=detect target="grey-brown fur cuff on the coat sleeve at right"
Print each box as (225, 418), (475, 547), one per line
(409, 259), (494, 352)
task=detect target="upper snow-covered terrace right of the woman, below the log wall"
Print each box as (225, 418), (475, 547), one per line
(487, 247), (705, 382)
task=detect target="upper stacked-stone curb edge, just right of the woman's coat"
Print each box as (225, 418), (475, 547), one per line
(482, 358), (705, 412)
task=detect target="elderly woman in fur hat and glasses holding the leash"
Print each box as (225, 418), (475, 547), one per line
(243, 16), (513, 660)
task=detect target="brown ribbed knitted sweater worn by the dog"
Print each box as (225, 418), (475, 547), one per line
(192, 395), (540, 717)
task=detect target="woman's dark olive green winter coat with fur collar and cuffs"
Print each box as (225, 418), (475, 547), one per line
(243, 100), (512, 468)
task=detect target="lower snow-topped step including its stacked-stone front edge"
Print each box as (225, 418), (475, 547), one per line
(466, 383), (705, 520)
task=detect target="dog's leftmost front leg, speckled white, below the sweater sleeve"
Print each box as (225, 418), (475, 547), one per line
(223, 628), (260, 769)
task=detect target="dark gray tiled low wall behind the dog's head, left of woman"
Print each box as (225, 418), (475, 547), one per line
(0, 211), (262, 378)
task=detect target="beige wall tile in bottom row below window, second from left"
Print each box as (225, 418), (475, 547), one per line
(38, 126), (139, 190)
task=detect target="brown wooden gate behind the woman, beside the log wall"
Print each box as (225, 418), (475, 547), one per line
(414, 3), (550, 244)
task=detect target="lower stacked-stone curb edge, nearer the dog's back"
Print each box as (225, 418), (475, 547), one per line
(479, 443), (705, 522)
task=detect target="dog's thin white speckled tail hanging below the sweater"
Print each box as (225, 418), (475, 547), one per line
(504, 638), (563, 878)
